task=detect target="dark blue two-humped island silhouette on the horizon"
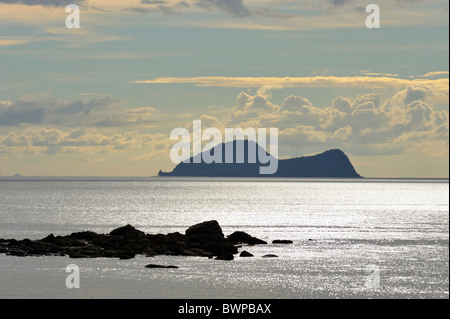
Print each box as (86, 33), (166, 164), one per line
(158, 140), (362, 178)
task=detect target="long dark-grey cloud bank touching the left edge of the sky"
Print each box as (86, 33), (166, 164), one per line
(0, 95), (155, 127)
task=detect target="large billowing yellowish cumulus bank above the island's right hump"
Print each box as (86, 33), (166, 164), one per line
(192, 85), (449, 157)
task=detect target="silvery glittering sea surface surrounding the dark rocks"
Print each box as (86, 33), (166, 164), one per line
(0, 178), (449, 299)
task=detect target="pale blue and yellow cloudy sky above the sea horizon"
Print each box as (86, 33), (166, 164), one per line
(0, 0), (449, 178)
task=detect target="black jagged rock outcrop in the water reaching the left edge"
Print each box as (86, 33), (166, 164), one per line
(0, 220), (274, 260)
